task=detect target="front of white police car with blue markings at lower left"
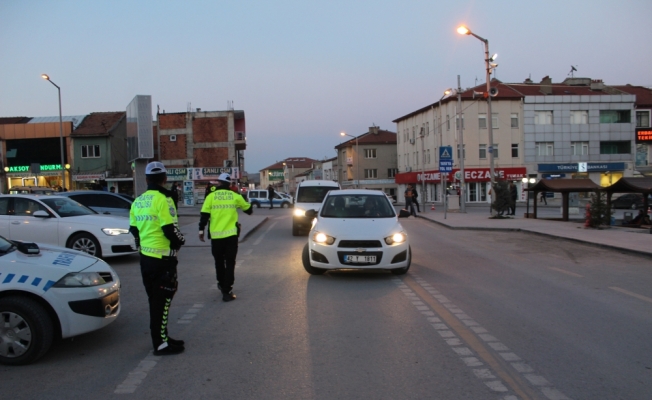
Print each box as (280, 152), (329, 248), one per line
(0, 236), (120, 365)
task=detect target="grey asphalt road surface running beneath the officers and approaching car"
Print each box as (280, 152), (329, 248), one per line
(0, 209), (652, 400)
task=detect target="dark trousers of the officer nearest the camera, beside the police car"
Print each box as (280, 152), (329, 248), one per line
(140, 254), (178, 350)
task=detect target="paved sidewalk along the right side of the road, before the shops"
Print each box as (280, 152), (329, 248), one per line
(410, 201), (652, 256)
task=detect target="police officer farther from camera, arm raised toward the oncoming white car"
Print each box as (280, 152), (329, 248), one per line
(199, 174), (253, 301)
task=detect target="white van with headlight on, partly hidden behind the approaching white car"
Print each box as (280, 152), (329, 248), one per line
(292, 180), (340, 236)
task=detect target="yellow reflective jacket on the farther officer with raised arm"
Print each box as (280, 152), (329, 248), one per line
(201, 189), (251, 239)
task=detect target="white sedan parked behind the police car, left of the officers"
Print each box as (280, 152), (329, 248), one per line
(0, 195), (137, 258)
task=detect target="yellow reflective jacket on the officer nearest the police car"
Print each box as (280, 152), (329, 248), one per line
(129, 190), (178, 258)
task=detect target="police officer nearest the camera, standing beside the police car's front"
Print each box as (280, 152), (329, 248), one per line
(129, 162), (185, 356)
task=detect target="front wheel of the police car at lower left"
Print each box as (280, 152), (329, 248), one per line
(0, 297), (54, 365)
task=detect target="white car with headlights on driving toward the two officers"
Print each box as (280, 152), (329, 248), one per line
(302, 189), (412, 275)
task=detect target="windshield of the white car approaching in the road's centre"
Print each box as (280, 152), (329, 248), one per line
(321, 194), (396, 218)
